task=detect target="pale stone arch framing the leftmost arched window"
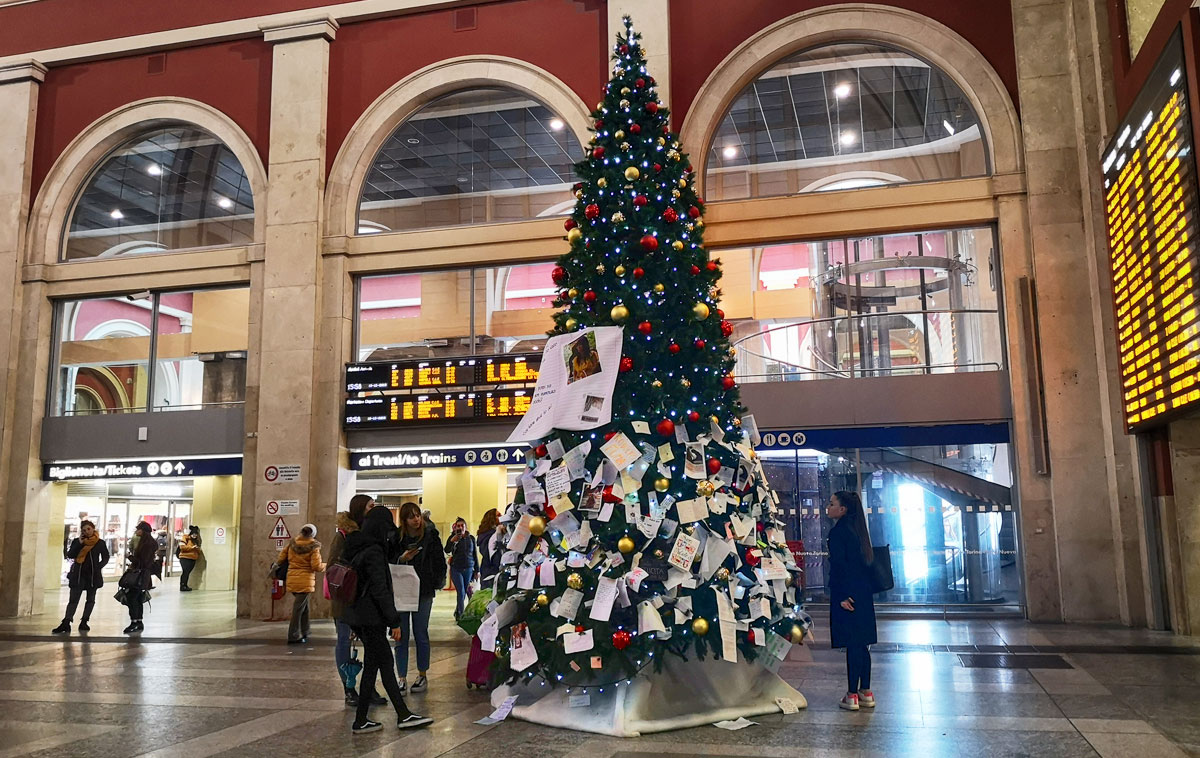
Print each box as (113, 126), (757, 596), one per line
(26, 97), (268, 264)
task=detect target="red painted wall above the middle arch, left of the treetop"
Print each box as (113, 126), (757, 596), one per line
(328, 0), (608, 171)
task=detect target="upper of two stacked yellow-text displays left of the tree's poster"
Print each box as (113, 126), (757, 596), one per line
(346, 353), (541, 393)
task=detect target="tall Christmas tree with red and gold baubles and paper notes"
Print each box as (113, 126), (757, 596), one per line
(481, 17), (806, 686)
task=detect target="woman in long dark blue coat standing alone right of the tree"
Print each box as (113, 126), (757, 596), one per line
(827, 492), (878, 710)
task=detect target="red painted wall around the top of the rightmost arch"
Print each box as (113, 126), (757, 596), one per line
(672, 0), (1016, 125)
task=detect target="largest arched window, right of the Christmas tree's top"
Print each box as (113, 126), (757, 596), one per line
(704, 43), (989, 200)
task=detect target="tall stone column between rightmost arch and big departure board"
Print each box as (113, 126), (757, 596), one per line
(1009, 0), (1146, 624)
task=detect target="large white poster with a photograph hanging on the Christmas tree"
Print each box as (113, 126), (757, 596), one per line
(508, 326), (623, 443)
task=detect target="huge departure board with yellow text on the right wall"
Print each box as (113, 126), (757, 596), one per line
(1102, 32), (1200, 433)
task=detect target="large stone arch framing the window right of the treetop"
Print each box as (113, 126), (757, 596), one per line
(679, 2), (1025, 195)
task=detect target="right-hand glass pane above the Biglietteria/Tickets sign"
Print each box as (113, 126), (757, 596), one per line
(154, 287), (250, 410)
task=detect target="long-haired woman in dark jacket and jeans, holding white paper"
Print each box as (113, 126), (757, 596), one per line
(389, 503), (446, 692)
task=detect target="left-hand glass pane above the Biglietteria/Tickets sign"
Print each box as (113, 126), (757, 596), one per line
(52, 296), (154, 416)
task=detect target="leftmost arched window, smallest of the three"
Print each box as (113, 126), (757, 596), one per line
(62, 125), (254, 260)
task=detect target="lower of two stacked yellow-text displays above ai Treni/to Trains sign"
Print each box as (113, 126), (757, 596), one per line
(343, 390), (533, 429)
